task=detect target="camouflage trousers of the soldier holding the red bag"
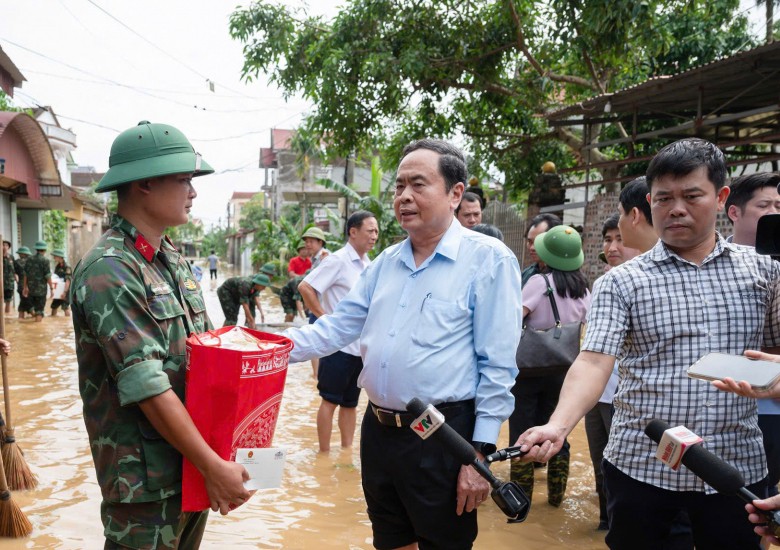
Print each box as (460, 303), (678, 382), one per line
(100, 494), (208, 550)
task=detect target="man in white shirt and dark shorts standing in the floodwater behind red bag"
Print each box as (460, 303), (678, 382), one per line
(298, 210), (379, 453)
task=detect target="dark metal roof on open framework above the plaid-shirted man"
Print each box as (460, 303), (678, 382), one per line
(546, 42), (780, 186)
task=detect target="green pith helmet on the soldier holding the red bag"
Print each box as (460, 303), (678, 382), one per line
(95, 120), (214, 193)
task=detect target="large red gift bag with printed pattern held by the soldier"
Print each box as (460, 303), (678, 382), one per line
(182, 327), (293, 512)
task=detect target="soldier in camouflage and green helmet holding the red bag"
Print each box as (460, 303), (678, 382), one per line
(70, 122), (250, 550)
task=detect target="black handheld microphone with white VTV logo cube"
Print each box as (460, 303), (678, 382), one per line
(406, 397), (531, 523)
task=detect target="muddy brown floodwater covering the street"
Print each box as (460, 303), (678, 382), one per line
(0, 270), (604, 550)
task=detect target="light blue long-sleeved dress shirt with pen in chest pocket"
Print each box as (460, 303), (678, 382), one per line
(285, 218), (523, 443)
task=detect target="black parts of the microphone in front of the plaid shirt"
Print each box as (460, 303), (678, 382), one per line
(645, 419), (780, 537)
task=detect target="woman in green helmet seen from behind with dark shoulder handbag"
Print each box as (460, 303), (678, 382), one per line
(509, 225), (590, 506)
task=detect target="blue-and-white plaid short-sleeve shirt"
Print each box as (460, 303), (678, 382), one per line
(582, 235), (780, 493)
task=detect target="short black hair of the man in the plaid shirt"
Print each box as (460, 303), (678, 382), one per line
(646, 138), (726, 191)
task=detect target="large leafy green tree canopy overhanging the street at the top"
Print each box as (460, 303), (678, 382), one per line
(230, 0), (752, 198)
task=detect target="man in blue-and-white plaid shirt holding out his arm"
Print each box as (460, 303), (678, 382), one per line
(517, 139), (780, 549)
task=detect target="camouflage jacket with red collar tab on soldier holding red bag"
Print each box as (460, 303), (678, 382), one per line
(70, 216), (212, 502)
